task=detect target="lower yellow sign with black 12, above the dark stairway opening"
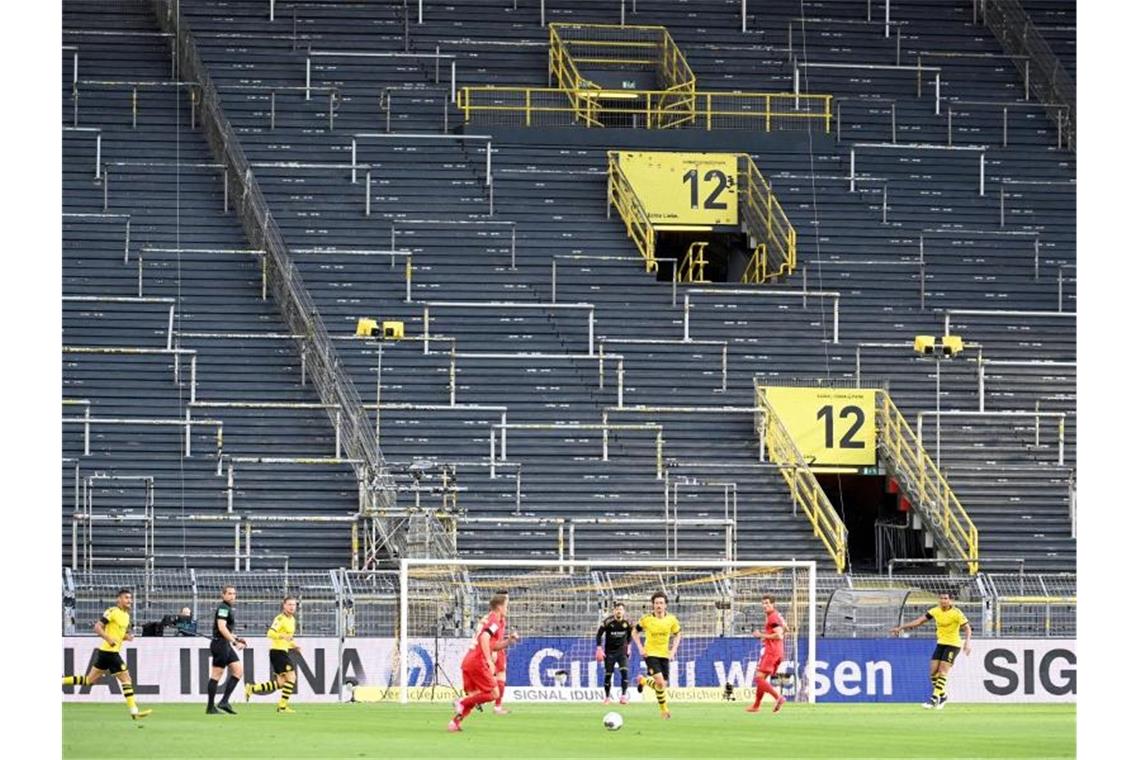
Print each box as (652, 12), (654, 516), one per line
(763, 387), (877, 466)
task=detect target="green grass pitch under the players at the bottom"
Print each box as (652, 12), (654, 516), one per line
(63, 701), (1076, 760)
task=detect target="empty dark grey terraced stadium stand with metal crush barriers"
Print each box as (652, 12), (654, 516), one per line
(63, 0), (1076, 572)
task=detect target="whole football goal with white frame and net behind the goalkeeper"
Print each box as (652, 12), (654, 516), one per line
(394, 558), (819, 703)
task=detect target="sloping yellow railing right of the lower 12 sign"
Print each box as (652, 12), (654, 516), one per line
(876, 391), (978, 574)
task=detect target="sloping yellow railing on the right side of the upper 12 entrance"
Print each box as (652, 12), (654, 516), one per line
(736, 153), (796, 284)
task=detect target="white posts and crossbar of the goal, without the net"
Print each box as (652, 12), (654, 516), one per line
(399, 558), (816, 704)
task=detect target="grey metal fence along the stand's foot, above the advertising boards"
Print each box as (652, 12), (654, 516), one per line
(62, 569), (1076, 638)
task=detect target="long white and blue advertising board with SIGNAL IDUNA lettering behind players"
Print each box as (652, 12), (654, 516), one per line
(63, 637), (1076, 702)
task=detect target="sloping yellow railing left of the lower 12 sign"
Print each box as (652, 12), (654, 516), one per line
(755, 383), (847, 573)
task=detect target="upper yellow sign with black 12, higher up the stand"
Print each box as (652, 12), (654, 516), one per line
(618, 150), (738, 224)
